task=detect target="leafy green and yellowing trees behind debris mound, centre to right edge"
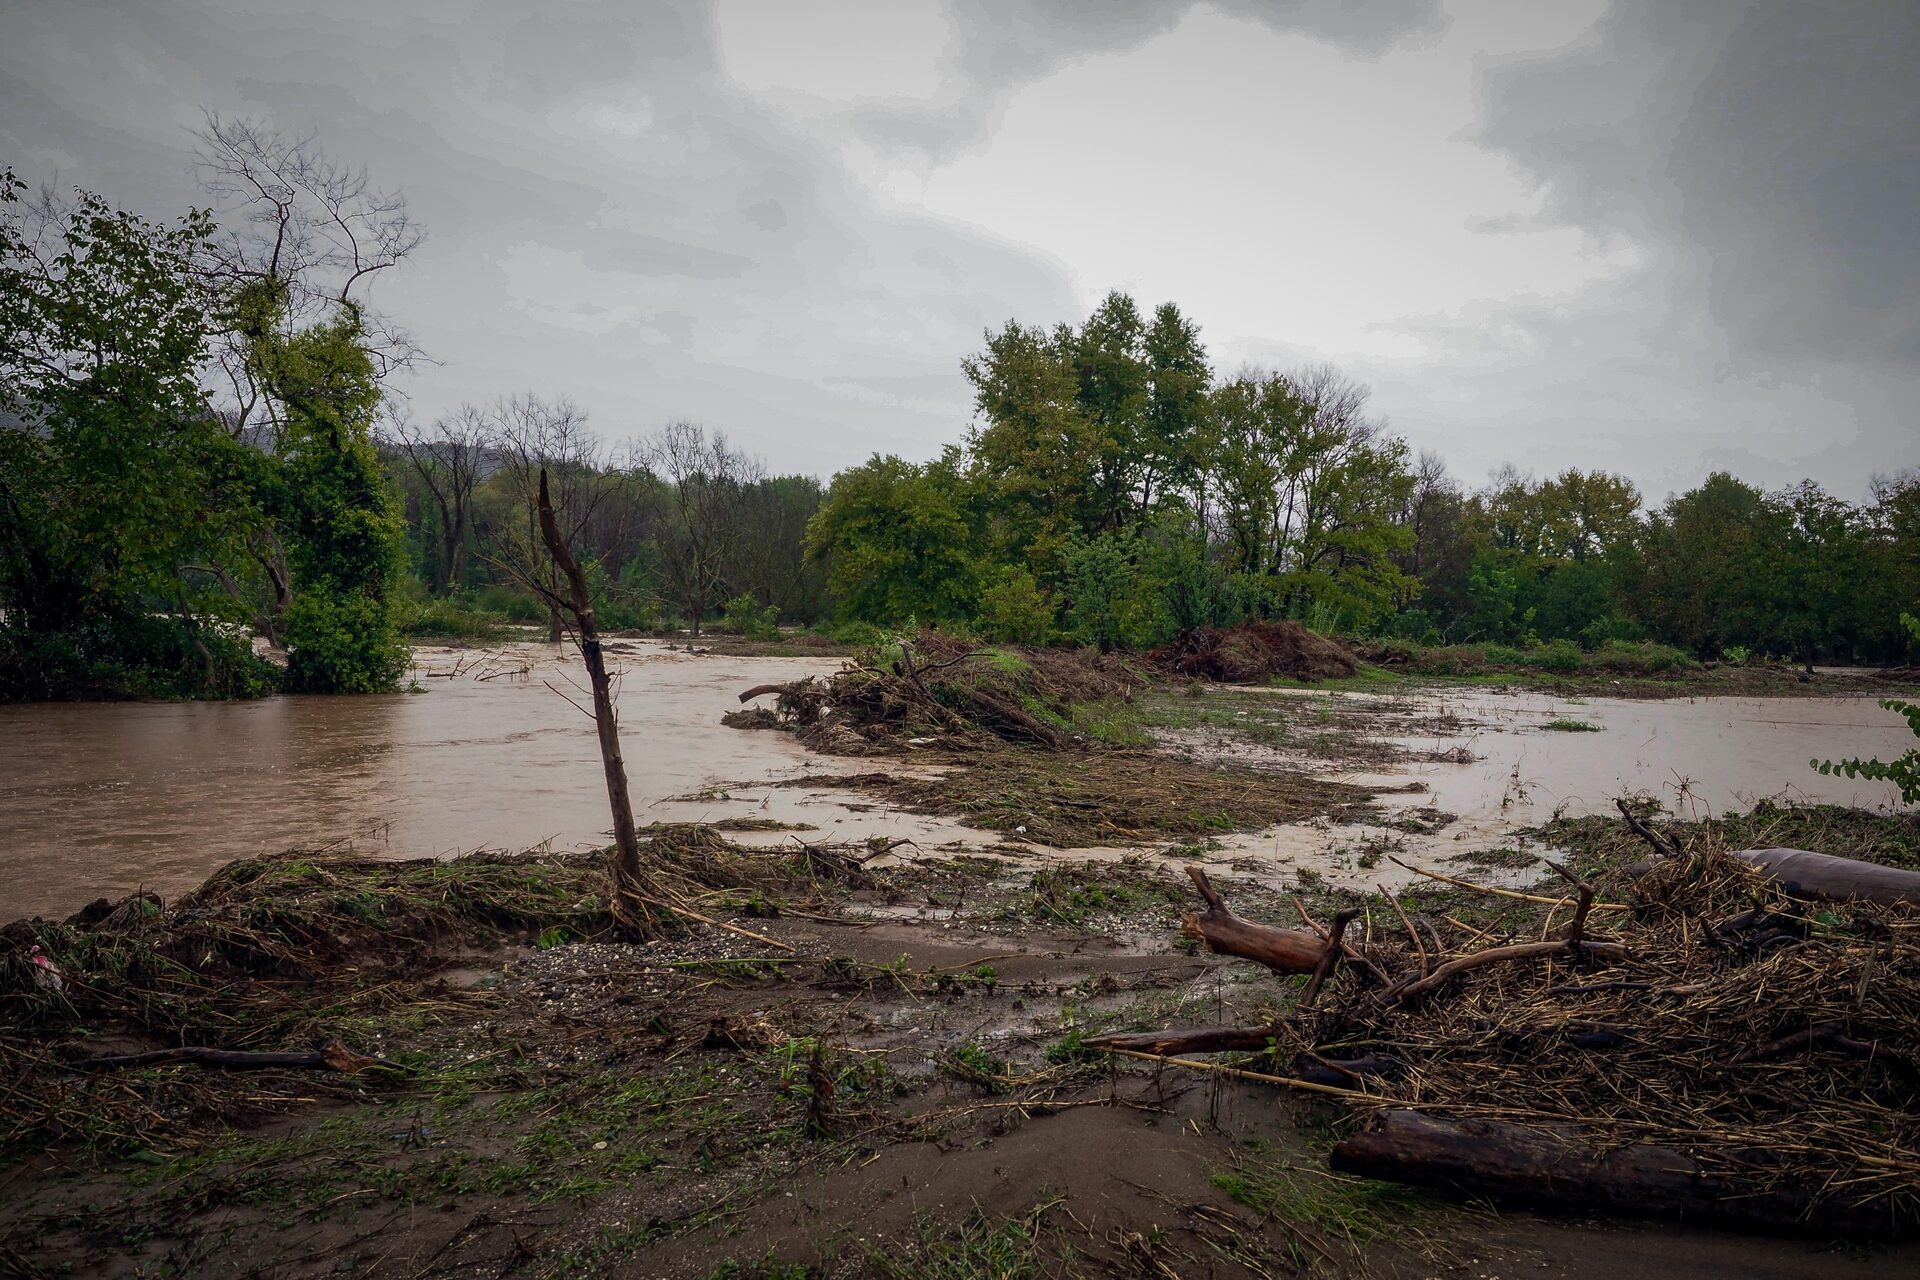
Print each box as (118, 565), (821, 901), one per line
(808, 294), (1920, 662)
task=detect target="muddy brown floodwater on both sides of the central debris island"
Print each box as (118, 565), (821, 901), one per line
(0, 643), (1912, 919)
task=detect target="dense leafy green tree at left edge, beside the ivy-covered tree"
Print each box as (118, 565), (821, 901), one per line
(0, 173), (271, 697)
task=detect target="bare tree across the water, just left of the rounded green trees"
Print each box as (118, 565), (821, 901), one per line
(639, 422), (766, 635)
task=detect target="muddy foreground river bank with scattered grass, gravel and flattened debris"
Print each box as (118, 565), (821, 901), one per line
(0, 810), (1920, 1280)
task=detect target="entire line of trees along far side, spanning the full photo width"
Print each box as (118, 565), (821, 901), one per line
(0, 128), (1920, 697)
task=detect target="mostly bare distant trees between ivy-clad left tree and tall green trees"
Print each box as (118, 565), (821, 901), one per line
(382, 393), (831, 639)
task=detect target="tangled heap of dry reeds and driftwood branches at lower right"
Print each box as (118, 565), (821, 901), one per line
(1096, 825), (1920, 1238)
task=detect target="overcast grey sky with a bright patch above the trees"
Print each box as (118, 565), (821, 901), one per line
(0, 0), (1920, 501)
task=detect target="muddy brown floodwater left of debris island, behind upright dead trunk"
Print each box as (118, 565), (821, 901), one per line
(0, 643), (993, 921)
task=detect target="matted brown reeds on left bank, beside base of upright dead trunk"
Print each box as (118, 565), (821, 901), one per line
(0, 836), (829, 1151)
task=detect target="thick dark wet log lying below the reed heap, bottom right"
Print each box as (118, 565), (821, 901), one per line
(1332, 1109), (1910, 1238)
